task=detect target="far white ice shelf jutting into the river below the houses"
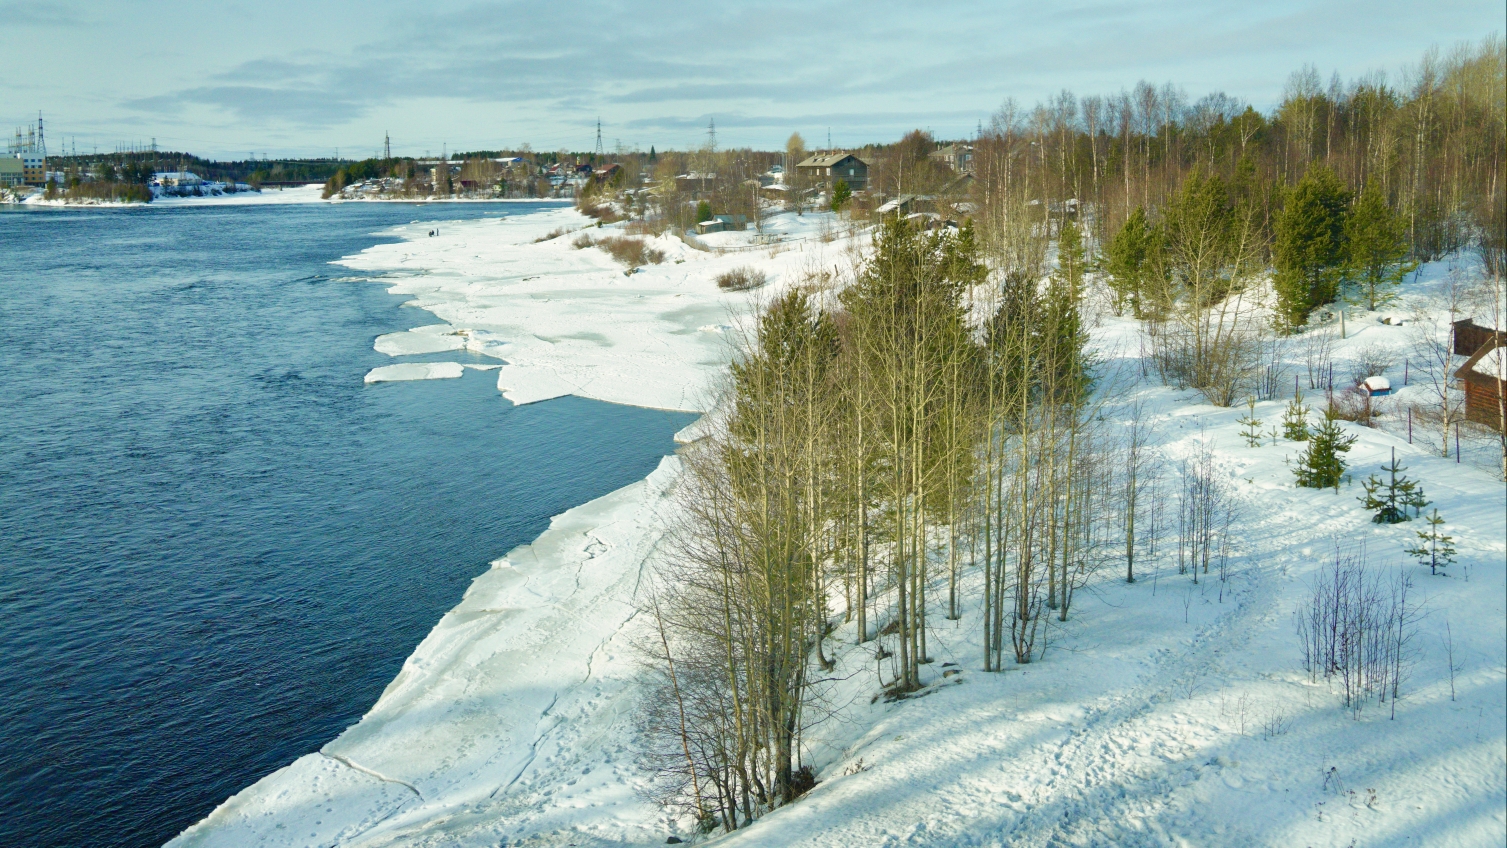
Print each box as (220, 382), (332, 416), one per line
(342, 209), (754, 411)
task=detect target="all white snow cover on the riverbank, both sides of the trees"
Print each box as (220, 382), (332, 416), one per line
(172, 209), (1507, 848)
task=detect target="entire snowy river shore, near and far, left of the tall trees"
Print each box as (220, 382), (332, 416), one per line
(172, 209), (862, 846)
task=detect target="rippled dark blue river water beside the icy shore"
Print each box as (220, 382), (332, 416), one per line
(0, 203), (690, 846)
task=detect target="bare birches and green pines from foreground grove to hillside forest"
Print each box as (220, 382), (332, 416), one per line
(629, 39), (1507, 831)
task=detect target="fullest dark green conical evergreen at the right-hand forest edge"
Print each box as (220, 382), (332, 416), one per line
(1272, 166), (1349, 330)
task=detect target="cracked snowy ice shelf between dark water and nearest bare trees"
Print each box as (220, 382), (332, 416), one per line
(172, 456), (678, 846)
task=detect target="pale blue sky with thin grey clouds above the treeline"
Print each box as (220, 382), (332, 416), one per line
(0, 0), (1507, 158)
